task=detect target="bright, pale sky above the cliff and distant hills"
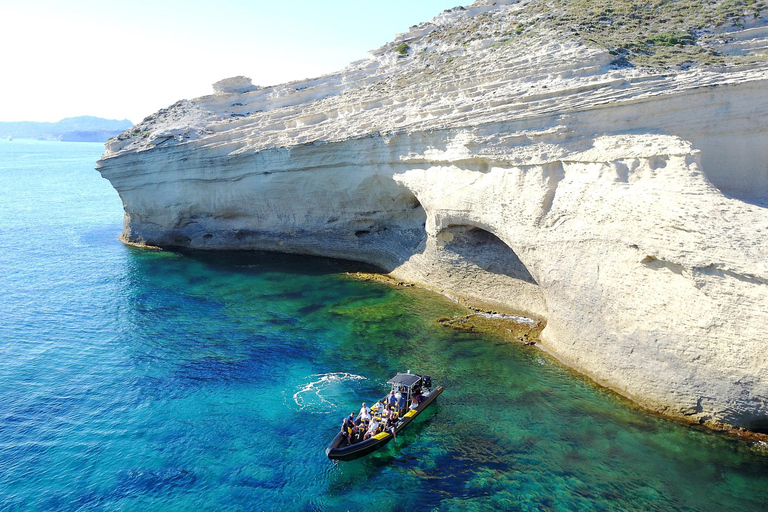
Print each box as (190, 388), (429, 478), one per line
(0, 0), (462, 122)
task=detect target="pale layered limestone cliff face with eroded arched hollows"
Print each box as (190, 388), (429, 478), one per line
(99, 2), (768, 428)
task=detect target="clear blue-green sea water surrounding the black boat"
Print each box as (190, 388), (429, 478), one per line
(0, 141), (768, 511)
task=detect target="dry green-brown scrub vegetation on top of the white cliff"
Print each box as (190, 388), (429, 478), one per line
(431, 0), (768, 68)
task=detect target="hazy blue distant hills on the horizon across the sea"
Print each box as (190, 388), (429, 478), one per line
(0, 116), (133, 142)
